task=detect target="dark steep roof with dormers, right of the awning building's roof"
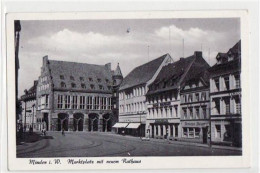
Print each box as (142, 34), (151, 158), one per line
(147, 52), (209, 95)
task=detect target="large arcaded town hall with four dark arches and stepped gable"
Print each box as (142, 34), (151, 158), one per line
(36, 56), (123, 132)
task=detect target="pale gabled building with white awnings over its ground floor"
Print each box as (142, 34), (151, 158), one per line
(117, 54), (173, 136)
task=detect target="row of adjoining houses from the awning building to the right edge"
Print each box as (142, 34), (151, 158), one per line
(114, 41), (242, 146)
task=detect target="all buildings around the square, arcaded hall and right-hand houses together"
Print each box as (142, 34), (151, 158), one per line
(21, 41), (242, 146)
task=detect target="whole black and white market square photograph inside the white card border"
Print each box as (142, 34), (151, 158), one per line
(14, 18), (242, 158)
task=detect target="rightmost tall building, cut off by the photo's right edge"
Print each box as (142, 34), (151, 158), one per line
(209, 41), (242, 146)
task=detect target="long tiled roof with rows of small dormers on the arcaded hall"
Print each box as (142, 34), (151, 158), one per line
(49, 60), (112, 92)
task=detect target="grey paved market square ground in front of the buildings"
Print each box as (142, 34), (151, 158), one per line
(17, 132), (242, 158)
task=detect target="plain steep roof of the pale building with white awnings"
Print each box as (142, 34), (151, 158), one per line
(120, 54), (168, 90)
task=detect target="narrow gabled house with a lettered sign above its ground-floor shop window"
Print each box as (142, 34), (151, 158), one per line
(180, 69), (210, 143)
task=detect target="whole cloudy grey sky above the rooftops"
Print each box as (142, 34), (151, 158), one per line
(18, 18), (240, 96)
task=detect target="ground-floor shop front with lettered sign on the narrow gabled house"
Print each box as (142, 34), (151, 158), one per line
(181, 120), (209, 144)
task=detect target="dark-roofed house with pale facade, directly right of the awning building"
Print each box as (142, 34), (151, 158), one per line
(146, 52), (208, 139)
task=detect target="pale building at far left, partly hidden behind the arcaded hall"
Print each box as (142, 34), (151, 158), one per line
(20, 80), (38, 130)
